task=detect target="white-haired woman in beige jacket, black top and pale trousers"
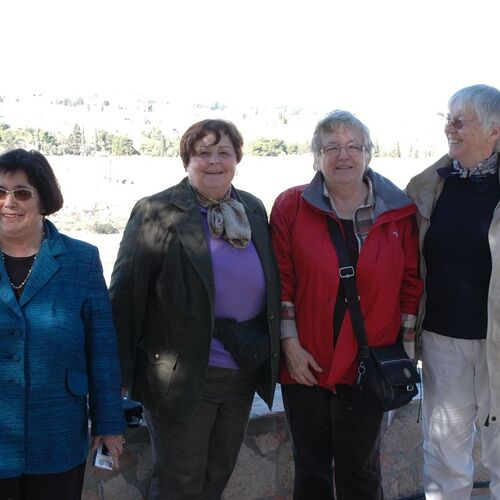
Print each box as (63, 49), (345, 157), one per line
(407, 85), (500, 500)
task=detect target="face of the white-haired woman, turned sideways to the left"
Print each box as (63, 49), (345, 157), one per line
(444, 107), (499, 168)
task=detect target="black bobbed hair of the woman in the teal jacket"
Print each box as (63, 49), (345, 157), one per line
(0, 149), (64, 215)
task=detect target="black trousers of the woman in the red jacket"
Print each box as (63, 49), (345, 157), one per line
(281, 384), (384, 500)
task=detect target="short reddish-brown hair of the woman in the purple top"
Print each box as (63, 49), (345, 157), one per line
(180, 120), (243, 168)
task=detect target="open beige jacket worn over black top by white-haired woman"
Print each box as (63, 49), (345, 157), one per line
(406, 155), (500, 422)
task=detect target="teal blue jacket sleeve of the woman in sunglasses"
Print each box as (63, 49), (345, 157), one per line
(82, 249), (125, 436)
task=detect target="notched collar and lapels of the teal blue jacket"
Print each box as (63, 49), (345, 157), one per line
(0, 220), (66, 311)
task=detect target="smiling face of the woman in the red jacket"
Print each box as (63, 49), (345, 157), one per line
(316, 126), (369, 190)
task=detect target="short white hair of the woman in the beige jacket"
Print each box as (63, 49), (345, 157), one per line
(448, 84), (500, 151)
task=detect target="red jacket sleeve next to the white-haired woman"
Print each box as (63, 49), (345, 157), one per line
(400, 215), (423, 317)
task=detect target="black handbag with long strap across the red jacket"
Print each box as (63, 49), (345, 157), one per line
(328, 218), (420, 411)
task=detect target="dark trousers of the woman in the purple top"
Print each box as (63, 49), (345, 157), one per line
(145, 367), (256, 500)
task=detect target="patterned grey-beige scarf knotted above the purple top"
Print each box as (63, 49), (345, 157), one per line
(191, 184), (252, 248)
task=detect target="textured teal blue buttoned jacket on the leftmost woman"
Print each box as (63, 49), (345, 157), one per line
(0, 221), (124, 478)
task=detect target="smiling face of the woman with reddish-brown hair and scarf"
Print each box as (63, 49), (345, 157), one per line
(186, 133), (237, 200)
